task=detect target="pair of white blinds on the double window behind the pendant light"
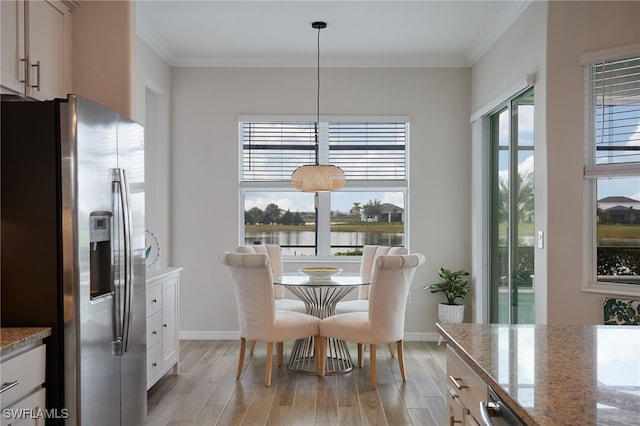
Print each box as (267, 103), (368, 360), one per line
(240, 122), (408, 182)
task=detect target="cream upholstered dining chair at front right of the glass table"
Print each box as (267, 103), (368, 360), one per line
(316, 253), (424, 389)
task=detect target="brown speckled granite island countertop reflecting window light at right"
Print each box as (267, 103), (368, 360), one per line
(437, 324), (640, 426)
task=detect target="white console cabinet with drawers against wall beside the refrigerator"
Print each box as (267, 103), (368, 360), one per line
(147, 268), (182, 390)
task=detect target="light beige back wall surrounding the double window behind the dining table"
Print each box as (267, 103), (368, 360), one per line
(171, 68), (471, 339)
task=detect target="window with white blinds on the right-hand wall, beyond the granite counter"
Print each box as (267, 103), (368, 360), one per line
(581, 45), (640, 294)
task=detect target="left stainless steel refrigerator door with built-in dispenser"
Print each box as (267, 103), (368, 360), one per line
(70, 97), (122, 426)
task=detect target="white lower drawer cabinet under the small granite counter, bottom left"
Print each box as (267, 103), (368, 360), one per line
(0, 345), (46, 426)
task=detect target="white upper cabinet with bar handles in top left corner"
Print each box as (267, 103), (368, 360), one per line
(1, 0), (71, 100)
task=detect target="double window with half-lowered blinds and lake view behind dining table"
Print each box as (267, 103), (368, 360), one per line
(238, 115), (409, 261)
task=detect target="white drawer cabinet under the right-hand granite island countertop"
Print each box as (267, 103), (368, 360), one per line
(447, 347), (488, 426)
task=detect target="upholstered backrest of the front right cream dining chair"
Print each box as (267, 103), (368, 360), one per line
(369, 253), (424, 342)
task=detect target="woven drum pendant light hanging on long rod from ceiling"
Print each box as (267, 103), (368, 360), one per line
(291, 22), (344, 192)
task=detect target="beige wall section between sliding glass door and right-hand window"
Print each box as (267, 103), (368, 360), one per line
(546, 1), (640, 324)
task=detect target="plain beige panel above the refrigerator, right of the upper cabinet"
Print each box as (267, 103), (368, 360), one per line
(72, 0), (135, 117)
